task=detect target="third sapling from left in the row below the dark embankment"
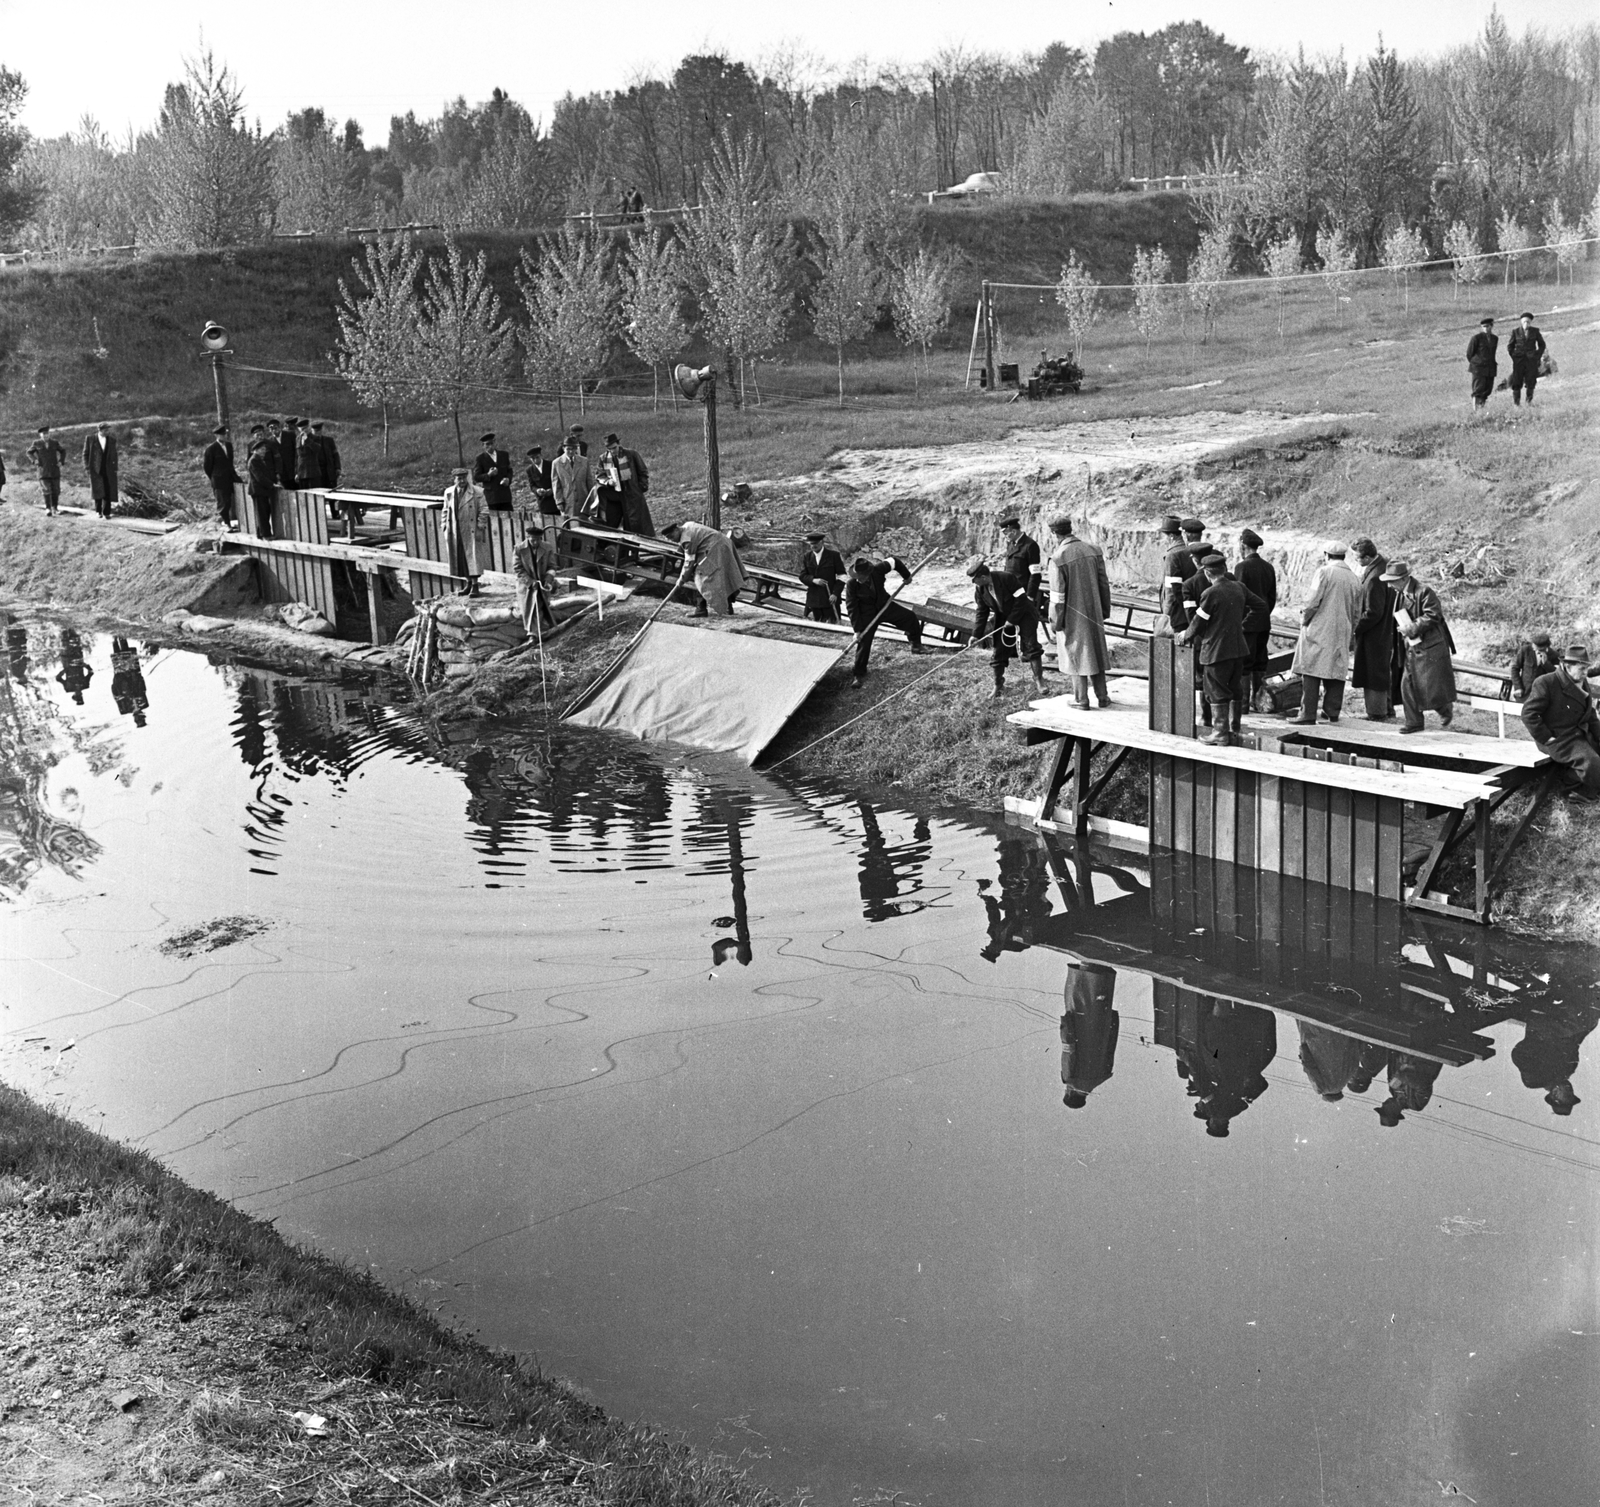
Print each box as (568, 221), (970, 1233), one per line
(517, 224), (616, 424)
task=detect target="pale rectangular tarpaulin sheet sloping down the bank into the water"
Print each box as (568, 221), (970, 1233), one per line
(566, 622), (838, 765)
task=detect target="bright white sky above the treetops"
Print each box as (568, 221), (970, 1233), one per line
(0, 0), (1597, 146)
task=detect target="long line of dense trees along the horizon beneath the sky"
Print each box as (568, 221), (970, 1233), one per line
(0, 13), (1600, 266)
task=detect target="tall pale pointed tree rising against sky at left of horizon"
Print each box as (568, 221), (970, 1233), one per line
(141, 51), (272, 246)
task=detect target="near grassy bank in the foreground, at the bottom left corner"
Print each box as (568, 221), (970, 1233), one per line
(0, 1086), (776, 1507)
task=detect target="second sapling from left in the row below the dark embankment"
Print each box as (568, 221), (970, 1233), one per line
(414, 235), (515, 466)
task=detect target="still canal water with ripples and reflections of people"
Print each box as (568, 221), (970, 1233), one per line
(0, 621), (1600, 1507)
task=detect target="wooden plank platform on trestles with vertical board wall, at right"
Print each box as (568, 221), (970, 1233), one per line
(1008, 637), (1550, 921)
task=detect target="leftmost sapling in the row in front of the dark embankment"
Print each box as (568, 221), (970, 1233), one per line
(334, 230), (422, 459)
